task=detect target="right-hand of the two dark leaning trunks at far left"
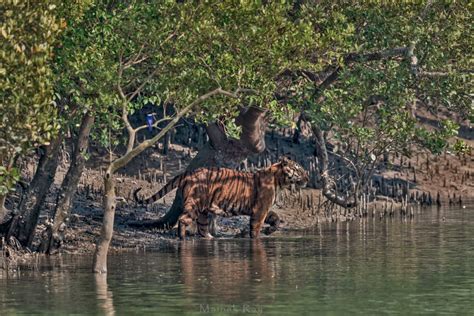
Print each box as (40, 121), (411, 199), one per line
(40, 113), (94, 253)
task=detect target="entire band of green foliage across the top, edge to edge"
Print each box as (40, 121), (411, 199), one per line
(0, 0), (473, 194)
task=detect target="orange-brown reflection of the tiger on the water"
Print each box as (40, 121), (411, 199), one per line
(179, 240), (275, 303)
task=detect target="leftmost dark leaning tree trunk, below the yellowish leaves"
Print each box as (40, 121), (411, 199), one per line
(7, 134), (63, 247)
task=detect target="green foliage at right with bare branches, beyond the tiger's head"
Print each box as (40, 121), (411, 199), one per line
(286, 1), (473, 188)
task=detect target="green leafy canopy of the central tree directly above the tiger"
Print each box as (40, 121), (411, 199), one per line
(56, 1), (313, 146)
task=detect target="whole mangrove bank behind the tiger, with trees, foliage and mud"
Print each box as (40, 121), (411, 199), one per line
(0, 0), (474, 272)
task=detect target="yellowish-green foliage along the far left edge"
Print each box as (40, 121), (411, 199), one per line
(0, 1), (62, 191)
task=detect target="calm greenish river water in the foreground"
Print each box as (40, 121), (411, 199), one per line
(0, 207), (474, 315)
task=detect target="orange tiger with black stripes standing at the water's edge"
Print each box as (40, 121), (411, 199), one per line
(133, 157), (309, 239)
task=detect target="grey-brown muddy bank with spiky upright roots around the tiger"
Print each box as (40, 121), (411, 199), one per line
(1, 127), (474, 260)
